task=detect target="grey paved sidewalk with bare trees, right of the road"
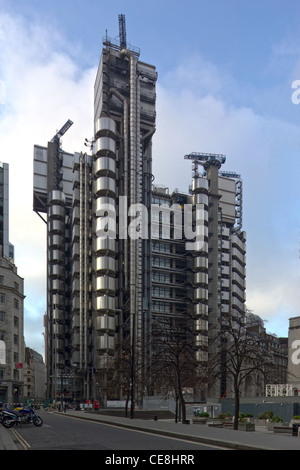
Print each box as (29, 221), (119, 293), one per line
(0, 410), (300, 450)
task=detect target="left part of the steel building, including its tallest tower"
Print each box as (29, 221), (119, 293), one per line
(34, 18), (157, 400)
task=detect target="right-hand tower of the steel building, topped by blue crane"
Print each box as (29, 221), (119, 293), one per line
(185, 153), (246, 397)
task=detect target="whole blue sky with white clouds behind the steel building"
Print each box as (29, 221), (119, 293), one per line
(0, 0), (300, 354)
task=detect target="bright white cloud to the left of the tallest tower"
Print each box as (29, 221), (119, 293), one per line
(0, 10), (96, 352)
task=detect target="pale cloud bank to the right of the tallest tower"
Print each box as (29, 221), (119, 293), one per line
(153, 56), (300, 335)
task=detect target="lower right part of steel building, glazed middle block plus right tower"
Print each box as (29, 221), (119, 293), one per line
(151, 153), (246, 399)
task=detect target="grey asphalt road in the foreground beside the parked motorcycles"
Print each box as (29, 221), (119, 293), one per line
(8, 411), (223, 454)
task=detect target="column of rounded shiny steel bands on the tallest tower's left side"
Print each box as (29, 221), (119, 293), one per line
(93, 117), (117, 356)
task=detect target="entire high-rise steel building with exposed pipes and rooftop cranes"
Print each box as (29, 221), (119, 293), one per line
(34, 15), (245, 403)
